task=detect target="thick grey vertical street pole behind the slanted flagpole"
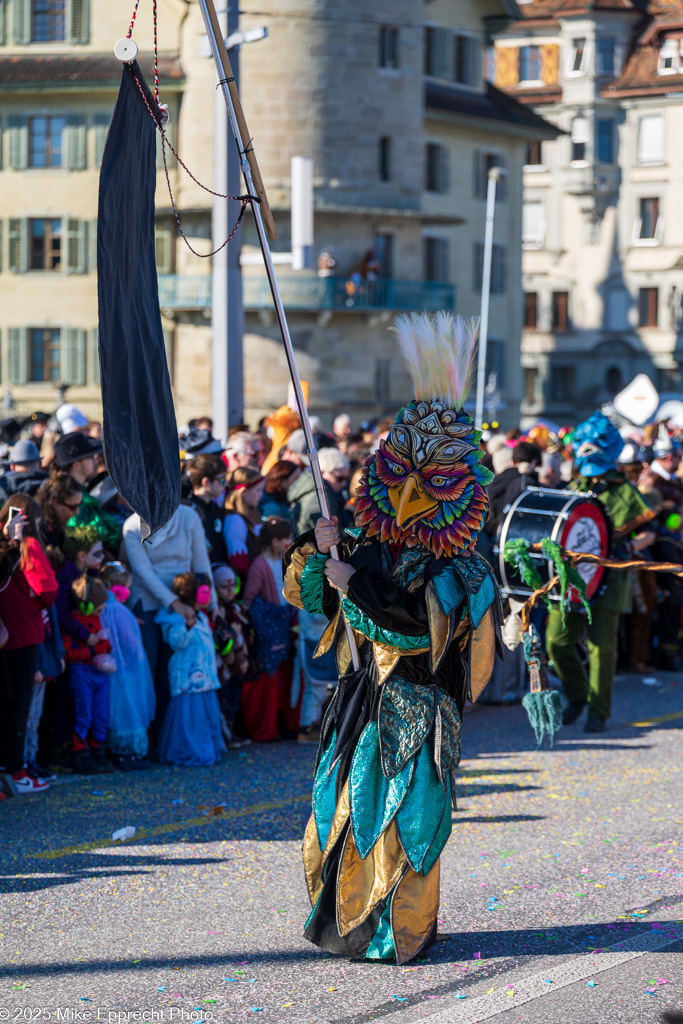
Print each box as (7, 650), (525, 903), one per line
(211, 7), (244, 438)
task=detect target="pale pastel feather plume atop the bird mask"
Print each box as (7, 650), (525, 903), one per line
(391, 311), (479, 409)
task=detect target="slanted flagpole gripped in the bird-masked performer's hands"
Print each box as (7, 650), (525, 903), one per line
(194, 0), (360, 669)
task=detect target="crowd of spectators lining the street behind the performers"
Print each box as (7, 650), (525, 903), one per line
(0, 404), (683, 799)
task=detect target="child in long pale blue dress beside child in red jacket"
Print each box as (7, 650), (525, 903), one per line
(99, 562), (156, 771)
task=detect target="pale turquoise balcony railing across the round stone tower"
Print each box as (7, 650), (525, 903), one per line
(159, 274), (456, 311)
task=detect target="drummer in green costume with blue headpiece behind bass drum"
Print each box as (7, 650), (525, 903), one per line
(546, 413), (655, 732)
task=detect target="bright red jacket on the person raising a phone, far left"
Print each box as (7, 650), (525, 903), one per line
(0, 537), (57, 650)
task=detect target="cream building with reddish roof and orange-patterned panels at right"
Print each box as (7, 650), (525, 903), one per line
(494, 0), (683, 423)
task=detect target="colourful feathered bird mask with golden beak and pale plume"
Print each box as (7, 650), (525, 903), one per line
(355, 312), (493, 558)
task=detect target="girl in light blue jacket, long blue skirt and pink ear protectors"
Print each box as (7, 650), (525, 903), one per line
(156, 572), (225, 765)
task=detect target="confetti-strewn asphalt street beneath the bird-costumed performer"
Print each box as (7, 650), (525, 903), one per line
(0, 674), (683, 1024)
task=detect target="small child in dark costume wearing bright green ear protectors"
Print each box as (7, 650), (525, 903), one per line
(212, 565), (251, 750)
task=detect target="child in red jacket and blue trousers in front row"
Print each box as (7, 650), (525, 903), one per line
(63, 573), (117, 775)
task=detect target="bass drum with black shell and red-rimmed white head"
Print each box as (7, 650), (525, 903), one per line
(495, 487), (611, 604)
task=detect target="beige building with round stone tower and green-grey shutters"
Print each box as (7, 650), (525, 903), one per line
(0, 0), (554, 423)
